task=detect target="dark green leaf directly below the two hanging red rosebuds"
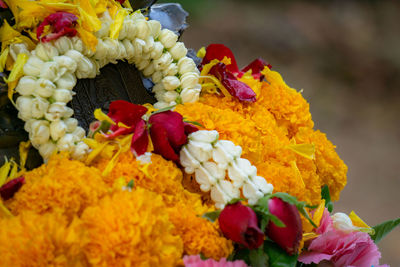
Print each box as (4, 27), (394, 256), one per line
(264, 240), (298, 267)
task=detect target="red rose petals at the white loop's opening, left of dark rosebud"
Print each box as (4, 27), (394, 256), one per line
(107, 100), (147, 138)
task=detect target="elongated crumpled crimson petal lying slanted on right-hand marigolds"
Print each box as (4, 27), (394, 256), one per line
(210, 63), (257, 102)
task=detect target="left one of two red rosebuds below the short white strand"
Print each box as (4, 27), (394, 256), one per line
(218, 202), (264, 249)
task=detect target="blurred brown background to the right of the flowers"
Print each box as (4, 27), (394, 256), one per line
(161, 0), (400, 266)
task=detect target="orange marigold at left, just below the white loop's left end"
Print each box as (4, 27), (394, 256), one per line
(6, 154), (109, 219)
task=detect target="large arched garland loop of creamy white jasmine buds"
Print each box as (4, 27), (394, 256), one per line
(11, 9), (201, 160)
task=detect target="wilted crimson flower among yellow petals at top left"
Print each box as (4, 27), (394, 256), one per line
(36, 11), (78, 42)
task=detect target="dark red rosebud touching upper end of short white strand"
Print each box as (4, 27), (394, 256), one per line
(149, 111), (187, 162)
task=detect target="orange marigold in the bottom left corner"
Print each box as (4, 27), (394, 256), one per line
(0, 211), (83, 266)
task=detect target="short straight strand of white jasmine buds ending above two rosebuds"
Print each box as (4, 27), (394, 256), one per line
(180, 130), (273, 209)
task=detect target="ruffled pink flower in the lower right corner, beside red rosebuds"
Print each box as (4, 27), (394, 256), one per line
(298, 209), (381, 267)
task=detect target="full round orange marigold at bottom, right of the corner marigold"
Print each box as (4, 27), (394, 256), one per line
(81, 188), (183, 266)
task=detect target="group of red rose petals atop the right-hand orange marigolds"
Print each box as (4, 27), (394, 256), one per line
(201, 44), (271, 102)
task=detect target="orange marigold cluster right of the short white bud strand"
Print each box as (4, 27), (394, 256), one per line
(176, 69), (347, 204)
